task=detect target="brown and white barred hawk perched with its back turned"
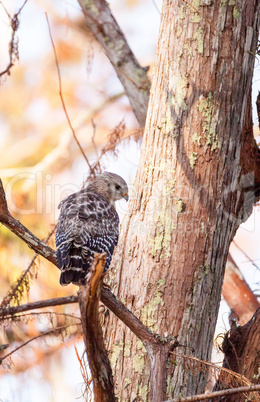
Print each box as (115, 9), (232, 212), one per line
(55, 172), (128, 285)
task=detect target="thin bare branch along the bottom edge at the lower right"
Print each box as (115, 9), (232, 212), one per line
(170, 385), (260, 402)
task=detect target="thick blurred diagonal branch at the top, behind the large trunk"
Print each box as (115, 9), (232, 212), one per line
(78, 0), (150, 127)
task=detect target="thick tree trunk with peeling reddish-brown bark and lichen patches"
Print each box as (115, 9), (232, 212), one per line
(106, 0), (258, 402)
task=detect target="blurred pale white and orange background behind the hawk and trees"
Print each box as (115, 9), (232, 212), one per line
(0, 0), (260, 402)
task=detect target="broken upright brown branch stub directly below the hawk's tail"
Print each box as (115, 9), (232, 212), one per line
(78, 254), (116, 402)
